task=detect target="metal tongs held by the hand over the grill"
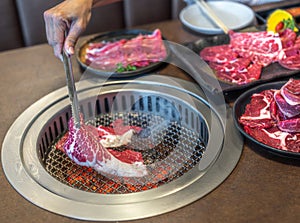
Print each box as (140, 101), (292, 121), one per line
(63, 50), (80, 128)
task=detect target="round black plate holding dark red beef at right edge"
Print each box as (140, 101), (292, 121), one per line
(233, 78), (300, 159)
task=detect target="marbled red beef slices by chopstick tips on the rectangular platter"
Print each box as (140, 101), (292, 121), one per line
(200, 31), (288, 85)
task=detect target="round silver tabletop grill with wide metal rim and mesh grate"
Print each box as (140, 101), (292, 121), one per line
(2, 75), (243, 221)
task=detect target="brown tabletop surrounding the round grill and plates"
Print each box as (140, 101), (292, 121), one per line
(0, 20), (300, 223)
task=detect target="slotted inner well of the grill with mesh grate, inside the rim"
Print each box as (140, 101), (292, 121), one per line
(38, 93), (208, 194)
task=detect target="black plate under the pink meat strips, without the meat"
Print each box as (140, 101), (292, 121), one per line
(76, 29), (169, 77)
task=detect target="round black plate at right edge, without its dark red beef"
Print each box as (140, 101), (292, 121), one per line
(233, 81), (300, 159)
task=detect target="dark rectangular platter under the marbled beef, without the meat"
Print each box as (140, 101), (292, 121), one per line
(186, 28), (300, 94)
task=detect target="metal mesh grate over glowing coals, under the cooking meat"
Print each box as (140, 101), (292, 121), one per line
(45, 112), (205, 194)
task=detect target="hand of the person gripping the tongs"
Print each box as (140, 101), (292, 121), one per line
(44, 0), (93, 60)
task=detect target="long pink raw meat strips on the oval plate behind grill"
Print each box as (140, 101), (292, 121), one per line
(85, 29), (167, 71)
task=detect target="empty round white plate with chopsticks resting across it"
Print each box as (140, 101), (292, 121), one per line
(179, 1), (255, 34)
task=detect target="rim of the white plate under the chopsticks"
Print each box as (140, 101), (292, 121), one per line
(179, 1), (255, 35)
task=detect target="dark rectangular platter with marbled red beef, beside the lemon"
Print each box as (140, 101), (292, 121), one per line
(187, 27), (300, 93)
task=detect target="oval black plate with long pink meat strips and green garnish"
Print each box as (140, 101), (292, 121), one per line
(76, 29), (168, 77)
